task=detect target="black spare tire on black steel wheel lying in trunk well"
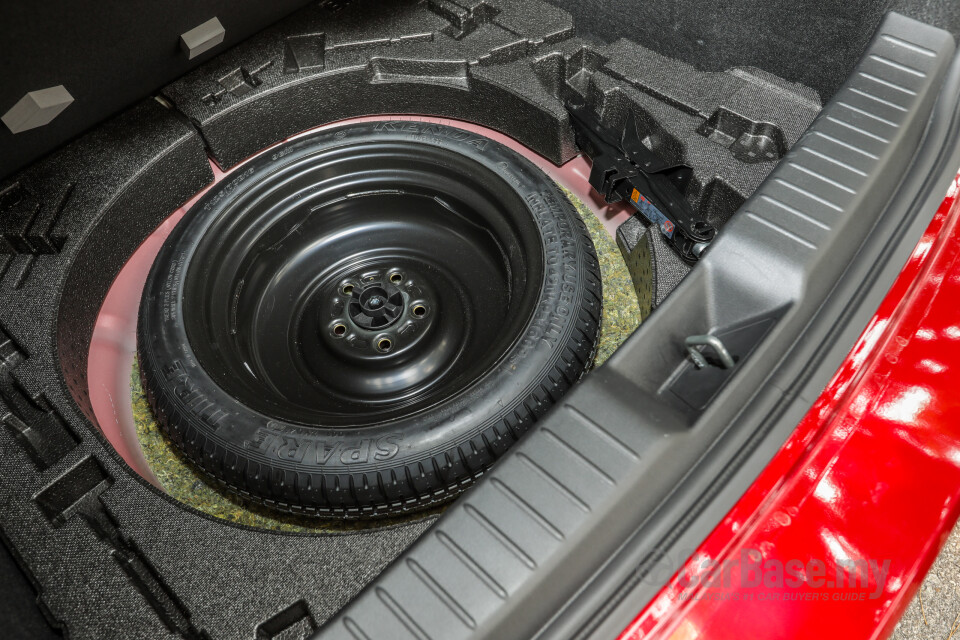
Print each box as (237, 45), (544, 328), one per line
(138, 121), (601, 517)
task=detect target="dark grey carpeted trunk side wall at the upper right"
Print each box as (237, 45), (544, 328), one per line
(552, 0), (960, 101)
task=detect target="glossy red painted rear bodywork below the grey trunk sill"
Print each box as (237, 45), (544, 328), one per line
(620, 171), (960, 640)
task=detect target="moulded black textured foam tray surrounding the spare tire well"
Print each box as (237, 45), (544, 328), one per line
(0, 0), (819, 638)
